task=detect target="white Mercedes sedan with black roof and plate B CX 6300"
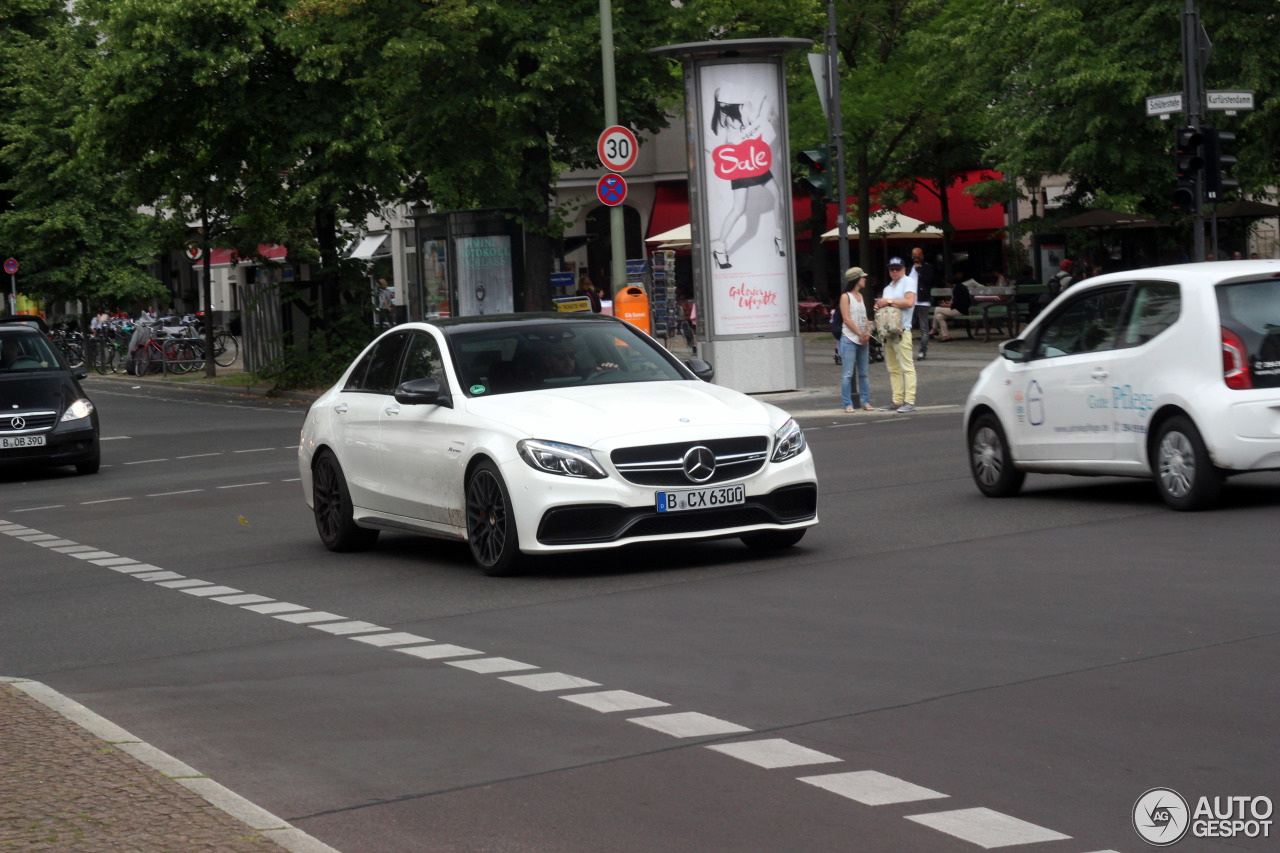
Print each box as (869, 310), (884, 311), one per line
(298, 314), (818, 575)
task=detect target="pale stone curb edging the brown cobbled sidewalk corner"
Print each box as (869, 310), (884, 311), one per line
(0, 676), (339, 853)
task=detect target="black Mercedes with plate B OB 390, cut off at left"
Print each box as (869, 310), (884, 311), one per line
(0, 324), (101, 474)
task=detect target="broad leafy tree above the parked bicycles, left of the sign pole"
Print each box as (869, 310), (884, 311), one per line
(84, 0), (403, 374)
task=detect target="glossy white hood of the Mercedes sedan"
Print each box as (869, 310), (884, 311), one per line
(465, 382), (787, 447)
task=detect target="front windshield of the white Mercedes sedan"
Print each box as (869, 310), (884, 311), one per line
(449, 323), (689, 397)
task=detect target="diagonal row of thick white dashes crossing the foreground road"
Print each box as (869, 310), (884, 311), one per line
(0, 522), (1090, 853)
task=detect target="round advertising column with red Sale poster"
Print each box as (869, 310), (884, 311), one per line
(650, 38), (812, 393)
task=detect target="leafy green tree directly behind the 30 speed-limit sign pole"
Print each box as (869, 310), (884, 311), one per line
(371, 0), (678, 309)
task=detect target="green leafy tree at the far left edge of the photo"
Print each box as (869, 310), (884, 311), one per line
(0, 4), (163, 317)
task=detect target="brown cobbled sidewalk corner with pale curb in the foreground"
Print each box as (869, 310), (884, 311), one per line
(0, 678), (337, 853)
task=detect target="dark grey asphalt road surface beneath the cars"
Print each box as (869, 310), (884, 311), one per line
(0, 365), (1280, 853)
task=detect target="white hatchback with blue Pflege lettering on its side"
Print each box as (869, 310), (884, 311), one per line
(965, 260), (1280, 510)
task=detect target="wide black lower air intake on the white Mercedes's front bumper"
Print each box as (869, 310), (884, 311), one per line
(538, 483), (818, 544)
